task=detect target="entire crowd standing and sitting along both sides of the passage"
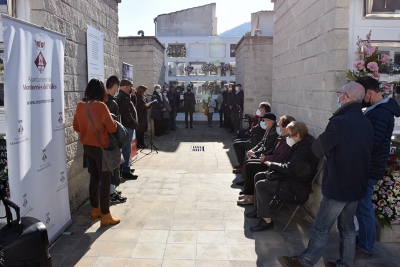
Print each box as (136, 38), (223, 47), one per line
(73, 76), (400, 267)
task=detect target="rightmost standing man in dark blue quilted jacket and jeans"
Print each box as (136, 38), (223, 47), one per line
(356, 76), (400, 259)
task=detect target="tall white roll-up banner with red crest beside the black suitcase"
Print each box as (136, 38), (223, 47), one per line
(3, 16), (71, 244)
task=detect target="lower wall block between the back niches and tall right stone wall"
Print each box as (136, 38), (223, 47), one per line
(236, 36), (274, 114)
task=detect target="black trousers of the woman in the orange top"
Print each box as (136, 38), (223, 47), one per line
(83, 145), (111, 214)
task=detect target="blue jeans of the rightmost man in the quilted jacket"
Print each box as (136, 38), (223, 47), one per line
(356, 179), (378, 254)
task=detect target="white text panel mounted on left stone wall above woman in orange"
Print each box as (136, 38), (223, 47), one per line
(86, 25), (105, 82)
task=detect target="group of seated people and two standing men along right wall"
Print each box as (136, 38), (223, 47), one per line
(228, 76), (400, 267)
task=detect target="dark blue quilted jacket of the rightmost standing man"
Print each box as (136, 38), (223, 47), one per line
(365, 98), (400, 180)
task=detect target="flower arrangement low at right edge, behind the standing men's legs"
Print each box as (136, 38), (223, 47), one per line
(372, 150), (400, 228)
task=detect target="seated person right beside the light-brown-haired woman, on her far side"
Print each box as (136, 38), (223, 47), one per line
(237, 115), (295, 205)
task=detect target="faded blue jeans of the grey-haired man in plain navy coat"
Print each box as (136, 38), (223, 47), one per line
(299, 196), (358, 267)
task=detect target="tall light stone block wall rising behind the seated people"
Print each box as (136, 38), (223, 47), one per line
(272, 0), (350, 216)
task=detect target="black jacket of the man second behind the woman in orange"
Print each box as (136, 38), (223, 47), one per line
(118, 90), (138, 130)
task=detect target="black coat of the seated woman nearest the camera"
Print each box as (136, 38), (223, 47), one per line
(269, 135), (318, 183)
